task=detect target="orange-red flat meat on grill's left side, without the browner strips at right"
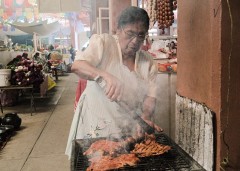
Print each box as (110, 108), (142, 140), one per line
(83, 138), (139, 171)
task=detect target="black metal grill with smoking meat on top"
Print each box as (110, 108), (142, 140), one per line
(71, 134), (205, 171)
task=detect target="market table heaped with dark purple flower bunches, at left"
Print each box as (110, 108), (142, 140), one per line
(0, 52), (56, 109)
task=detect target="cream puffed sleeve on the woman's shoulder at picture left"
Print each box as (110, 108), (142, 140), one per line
(75, 34), (104, 66)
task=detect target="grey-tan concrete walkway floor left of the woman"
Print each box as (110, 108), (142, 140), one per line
(0, 73), (78, 171)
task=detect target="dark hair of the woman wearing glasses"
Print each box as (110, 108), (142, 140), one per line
(118, 6), (149, 30)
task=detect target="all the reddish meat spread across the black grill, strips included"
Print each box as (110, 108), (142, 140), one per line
(83, 135), (171, 171)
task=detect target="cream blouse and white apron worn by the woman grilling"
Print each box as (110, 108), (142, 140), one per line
(66, 34), (157, 156)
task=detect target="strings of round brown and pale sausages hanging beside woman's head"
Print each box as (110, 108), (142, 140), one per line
(146, 0), (177, 34)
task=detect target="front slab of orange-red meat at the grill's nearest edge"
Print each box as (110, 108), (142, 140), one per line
(87, 154), (139, 171)
